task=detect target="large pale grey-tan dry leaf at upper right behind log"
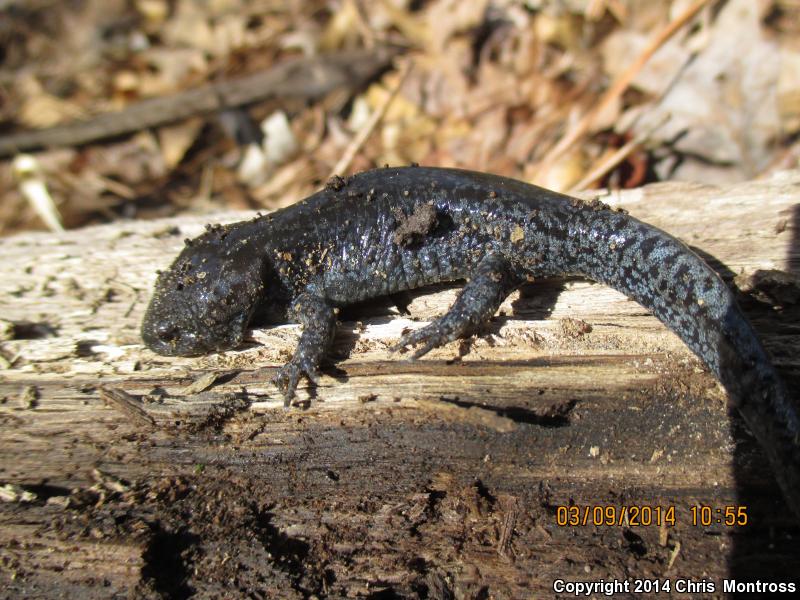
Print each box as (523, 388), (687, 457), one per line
(635, 0), (781, 183)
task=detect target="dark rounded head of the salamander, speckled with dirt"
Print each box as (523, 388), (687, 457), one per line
(142, 230), (264, 356)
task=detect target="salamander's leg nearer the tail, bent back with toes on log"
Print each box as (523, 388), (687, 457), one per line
(392, 256), (522, 359)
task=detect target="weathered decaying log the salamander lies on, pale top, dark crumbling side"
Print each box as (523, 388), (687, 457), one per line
(0, 172), (800, 598)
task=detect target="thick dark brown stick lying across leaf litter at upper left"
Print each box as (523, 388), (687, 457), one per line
(0, 50), (392, 157)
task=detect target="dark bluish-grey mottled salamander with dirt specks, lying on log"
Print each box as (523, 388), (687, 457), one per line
(142, 167), (800, 516)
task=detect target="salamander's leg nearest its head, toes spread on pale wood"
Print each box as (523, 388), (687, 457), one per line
(272, 292), (336, 406)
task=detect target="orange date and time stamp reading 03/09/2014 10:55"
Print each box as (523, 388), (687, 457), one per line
(556, 504), (748, 527)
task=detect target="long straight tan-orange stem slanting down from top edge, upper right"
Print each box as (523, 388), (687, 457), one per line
(536, 0), (710, 183)
